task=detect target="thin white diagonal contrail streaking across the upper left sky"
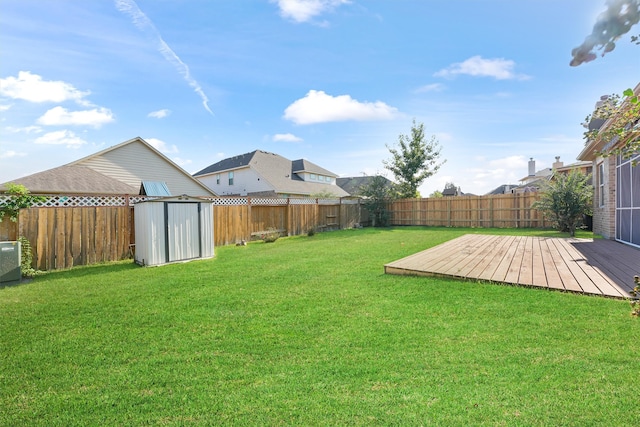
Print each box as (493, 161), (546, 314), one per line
(115, 0), (213, 115)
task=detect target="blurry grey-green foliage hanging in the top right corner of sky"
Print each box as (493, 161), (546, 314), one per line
(570, 0), (640, 67)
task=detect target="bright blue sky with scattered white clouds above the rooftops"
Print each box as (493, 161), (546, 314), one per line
(0, 0), (640, 196)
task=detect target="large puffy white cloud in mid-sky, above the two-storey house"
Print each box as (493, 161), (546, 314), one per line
(284, 90), (398, 125)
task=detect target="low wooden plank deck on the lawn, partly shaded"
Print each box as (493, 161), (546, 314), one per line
(384, 234), (640, 298)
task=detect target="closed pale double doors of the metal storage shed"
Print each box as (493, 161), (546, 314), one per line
(167, 202), (201, 262)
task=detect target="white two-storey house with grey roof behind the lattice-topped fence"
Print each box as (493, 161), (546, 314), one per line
(193, 150), (349, 197)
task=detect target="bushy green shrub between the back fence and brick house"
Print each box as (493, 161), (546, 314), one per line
(534, 169), (593, 237)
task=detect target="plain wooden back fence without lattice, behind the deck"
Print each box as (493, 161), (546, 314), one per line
(389, 193), (550, 228)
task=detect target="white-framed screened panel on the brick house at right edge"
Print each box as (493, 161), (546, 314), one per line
(616, 153), (640, 247)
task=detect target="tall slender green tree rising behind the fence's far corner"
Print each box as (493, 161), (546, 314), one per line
(383, 119), (444, 199)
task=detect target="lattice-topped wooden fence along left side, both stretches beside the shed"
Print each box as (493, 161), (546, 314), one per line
(0, 196), (361, 270)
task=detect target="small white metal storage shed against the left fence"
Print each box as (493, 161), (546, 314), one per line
(134, 195), (214, 266)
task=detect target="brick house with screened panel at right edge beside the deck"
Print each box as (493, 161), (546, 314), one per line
(578, 83), (640, 247)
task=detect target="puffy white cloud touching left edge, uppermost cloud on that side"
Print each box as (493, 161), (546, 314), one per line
(0, 71), (90, 105)
